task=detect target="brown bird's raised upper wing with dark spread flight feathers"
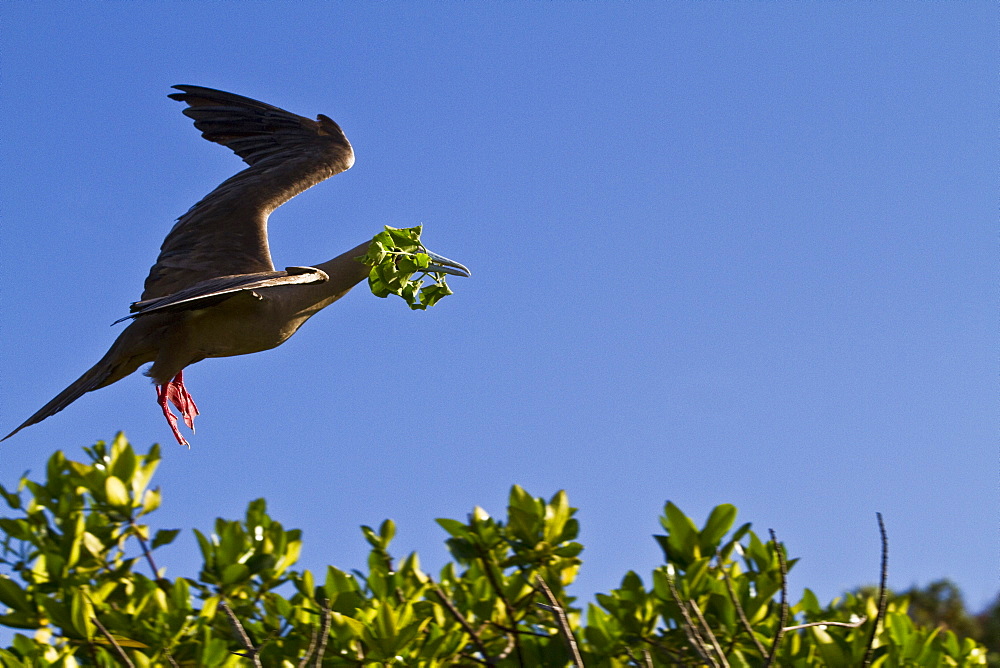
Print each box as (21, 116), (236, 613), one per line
(142, 86), (354, 301)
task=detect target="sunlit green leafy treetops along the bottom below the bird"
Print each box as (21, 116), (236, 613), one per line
(0, 435), (986, 668)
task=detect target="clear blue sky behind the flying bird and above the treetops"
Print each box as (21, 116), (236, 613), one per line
(0, 2), (1000, 607)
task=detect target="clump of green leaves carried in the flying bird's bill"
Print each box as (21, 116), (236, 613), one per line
(361, 225), (453, 310)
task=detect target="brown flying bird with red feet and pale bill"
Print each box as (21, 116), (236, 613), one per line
(0, 85), (470, 445)
